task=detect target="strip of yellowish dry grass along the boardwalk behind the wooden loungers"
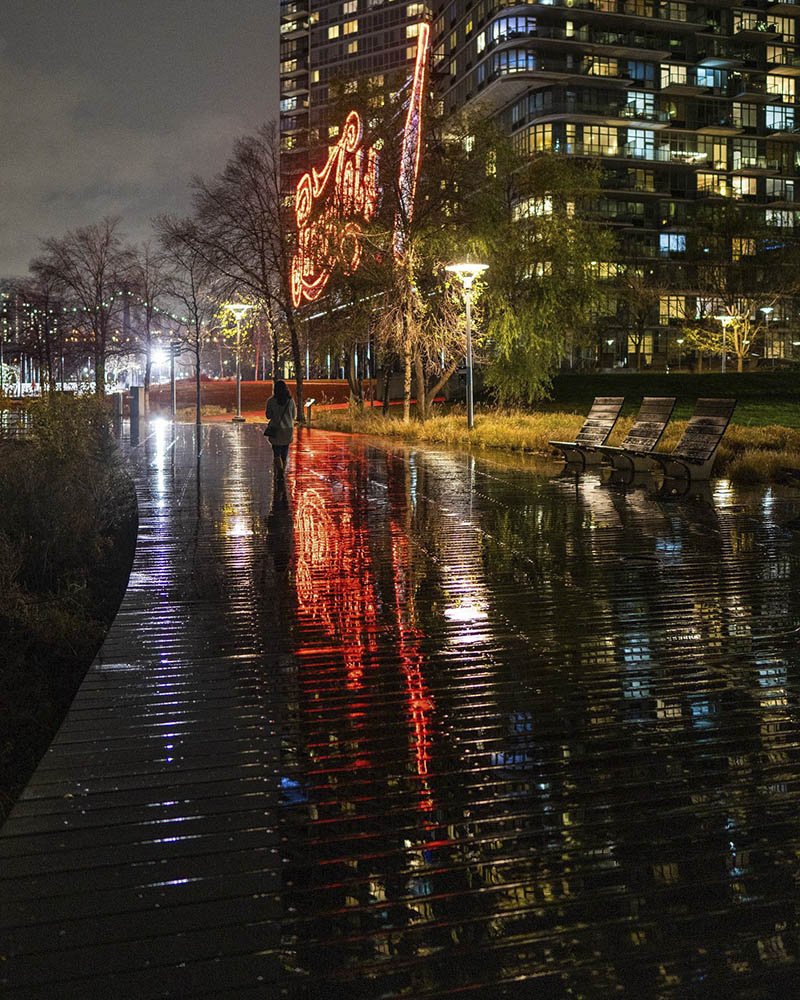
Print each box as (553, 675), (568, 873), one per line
(314, 404), (800, 483)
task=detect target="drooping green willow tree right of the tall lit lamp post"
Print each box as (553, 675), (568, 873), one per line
(461, 130), (613, 403)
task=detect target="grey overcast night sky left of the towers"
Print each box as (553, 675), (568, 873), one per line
(0, 0), (279, 279)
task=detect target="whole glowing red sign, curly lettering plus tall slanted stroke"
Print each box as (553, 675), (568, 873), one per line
(291, 24), (430, 308)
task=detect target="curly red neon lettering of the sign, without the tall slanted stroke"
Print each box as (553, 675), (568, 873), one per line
(291, 111), (381, 307)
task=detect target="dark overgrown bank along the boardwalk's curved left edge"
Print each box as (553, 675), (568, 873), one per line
(0, 398), (136, 820)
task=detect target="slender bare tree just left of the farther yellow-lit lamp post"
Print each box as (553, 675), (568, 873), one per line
(156, 216), (220, 424)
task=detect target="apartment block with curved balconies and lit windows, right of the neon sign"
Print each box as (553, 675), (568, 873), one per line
(433, 0), (800, 363)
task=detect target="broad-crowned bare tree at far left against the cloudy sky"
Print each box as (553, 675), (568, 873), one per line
(31, 218), (132, 396)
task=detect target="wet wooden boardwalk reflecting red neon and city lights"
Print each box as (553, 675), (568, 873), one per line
(0, 423), (800, 1000)
